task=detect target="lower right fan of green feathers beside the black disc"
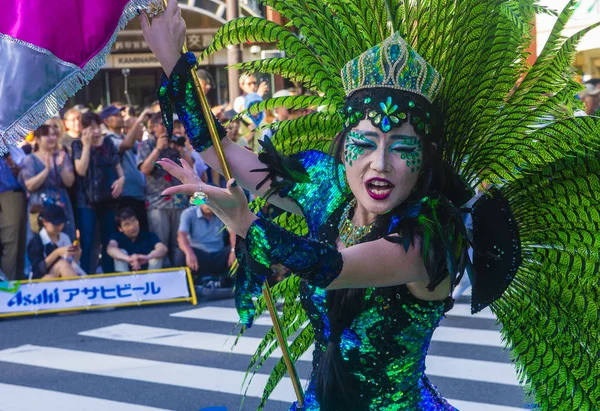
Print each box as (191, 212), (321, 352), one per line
(491, 139), (600, 410)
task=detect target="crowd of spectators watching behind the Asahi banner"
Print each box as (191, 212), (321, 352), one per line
(0, 70), (305, 287)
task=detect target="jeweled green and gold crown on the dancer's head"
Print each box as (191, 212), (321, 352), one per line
(341, 33), (442, 103)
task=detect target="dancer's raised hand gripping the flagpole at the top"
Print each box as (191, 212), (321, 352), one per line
(140, 0), (186, 76)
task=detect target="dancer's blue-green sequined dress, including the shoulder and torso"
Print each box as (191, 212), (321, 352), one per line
(260, 151), (462, 411)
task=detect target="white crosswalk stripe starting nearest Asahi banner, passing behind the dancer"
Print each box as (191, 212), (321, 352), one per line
(171, 304), (504, 347)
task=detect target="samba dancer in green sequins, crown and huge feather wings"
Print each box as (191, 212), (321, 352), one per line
(142, 0), (600, 411)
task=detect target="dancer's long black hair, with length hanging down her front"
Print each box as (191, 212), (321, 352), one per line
(315, 108), (444, 411)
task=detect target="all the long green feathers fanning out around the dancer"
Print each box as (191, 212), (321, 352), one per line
(206, 0), (600, 410)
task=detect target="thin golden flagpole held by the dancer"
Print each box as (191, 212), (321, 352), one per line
(152, 0), (304, 409)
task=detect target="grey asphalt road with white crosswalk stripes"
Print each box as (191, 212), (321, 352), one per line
(0, 294), (525, 411)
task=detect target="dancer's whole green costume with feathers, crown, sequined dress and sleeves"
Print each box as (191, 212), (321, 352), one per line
(161, 0), (600, 411)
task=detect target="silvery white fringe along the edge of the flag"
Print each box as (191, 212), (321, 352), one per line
(0, 0), (162, 154)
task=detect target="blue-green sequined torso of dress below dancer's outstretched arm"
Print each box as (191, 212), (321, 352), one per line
(301, 283), (453, 411)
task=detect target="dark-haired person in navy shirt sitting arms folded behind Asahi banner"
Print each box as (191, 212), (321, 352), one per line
(107, 207), (167, 272)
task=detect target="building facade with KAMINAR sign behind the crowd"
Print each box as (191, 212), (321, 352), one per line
(67, 0), (278, 108)
